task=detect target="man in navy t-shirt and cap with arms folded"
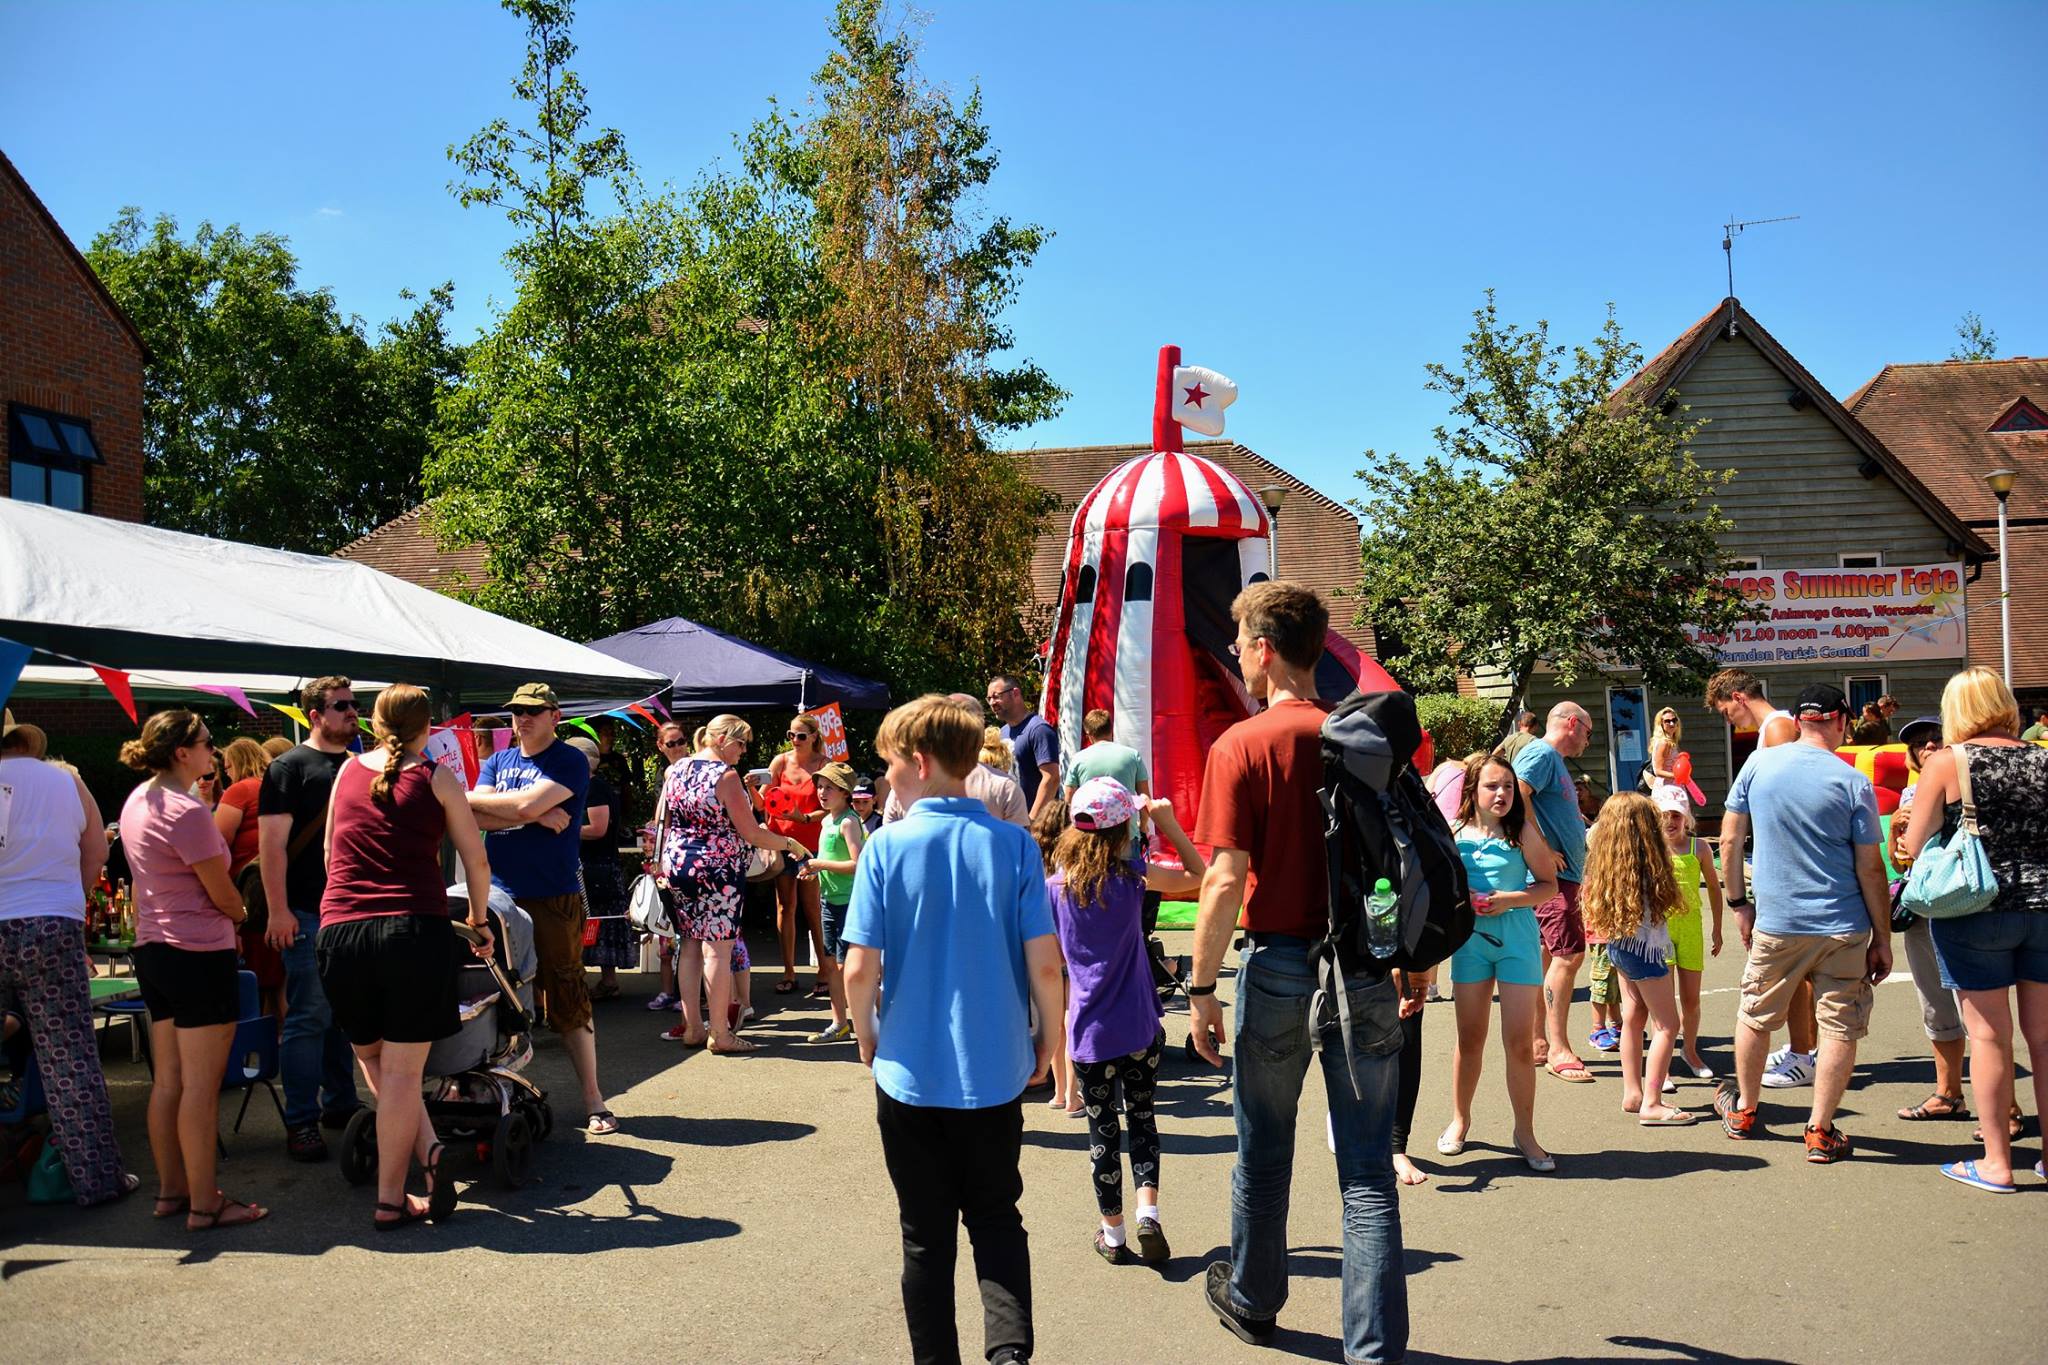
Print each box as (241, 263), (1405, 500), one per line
(469, 684), (618, 1134)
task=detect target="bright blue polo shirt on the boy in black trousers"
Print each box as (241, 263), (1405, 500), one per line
(842, 796), (1053, 1109)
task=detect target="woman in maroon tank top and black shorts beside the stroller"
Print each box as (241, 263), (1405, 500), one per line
(315, 684), (492, 1232)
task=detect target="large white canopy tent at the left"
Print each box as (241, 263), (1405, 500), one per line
(0, 499), (670, 710)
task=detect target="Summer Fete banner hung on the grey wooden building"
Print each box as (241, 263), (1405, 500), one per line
(1686, 563), (1968, 667)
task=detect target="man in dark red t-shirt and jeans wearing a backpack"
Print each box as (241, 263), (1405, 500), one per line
(1188, 583), (1407, 1361)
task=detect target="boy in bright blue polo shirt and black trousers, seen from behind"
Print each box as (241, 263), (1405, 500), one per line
(840, 696), (1065, 1363)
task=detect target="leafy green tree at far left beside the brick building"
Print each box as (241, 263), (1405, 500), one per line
(86, 209), (463, 553)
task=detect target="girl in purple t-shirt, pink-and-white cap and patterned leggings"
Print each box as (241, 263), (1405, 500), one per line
(1047, 778), (1206, 1265)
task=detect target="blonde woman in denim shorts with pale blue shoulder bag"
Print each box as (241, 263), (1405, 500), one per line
(1901, 667), (2048, 1193)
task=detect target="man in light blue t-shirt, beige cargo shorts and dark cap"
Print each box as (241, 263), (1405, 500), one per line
(1714, 684), (1892, 1164)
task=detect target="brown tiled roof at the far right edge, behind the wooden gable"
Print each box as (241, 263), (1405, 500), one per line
(1849, 356), (2048, 527)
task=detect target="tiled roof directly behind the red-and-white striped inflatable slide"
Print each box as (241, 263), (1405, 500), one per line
(1016, 440), (1376, 653)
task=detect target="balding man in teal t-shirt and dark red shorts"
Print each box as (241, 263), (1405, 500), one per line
(1513, 702), (1593, 1081)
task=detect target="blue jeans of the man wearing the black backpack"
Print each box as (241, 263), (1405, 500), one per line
(1229, 941), (1409, 1365)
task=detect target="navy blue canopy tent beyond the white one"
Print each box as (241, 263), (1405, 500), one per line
(590, 616), (889, 712)
